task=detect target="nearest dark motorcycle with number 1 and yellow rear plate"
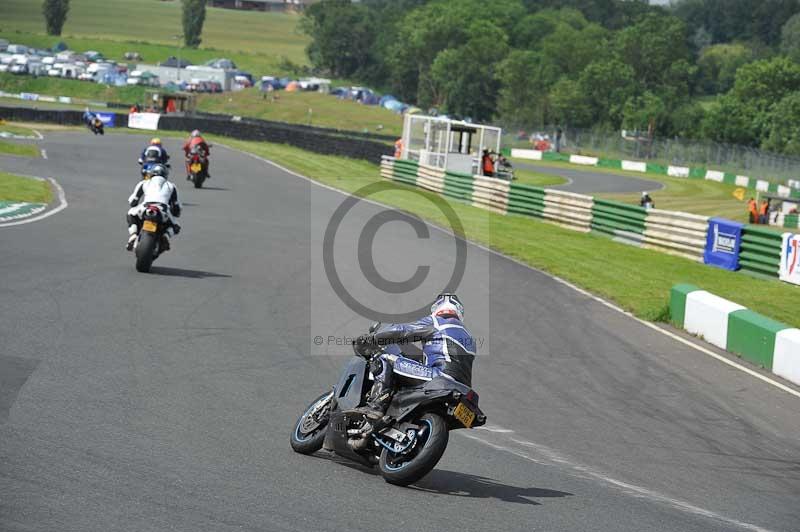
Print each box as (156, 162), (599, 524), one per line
(291, 323), (486, 486)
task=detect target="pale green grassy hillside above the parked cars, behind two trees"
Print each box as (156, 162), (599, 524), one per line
(0, 0), (309, 74)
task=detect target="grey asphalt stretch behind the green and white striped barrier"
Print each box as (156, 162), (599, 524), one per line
(513, 161), (664, 194)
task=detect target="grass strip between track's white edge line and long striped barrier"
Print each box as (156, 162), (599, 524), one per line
(206, 138), (800, 327)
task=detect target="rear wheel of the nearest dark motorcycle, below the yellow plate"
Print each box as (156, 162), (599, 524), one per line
(378, 412), (449, 486)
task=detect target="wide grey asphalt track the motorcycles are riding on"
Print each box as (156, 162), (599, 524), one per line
(0, 132), (800, 532)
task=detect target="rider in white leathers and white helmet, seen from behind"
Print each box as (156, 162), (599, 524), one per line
(125, 164), (182, 251)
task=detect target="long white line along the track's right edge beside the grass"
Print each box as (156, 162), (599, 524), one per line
(217, 142), (800, 398)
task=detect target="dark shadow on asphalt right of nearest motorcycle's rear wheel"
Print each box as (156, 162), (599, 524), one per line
(409, 469), (573, 506)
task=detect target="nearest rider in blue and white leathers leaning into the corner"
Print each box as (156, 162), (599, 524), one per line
(356, 293), (476, 421)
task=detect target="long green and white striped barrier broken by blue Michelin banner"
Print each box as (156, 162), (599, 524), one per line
(380, 157), (788, 278)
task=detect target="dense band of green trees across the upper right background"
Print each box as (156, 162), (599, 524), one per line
(301, 0), (800, 154)
